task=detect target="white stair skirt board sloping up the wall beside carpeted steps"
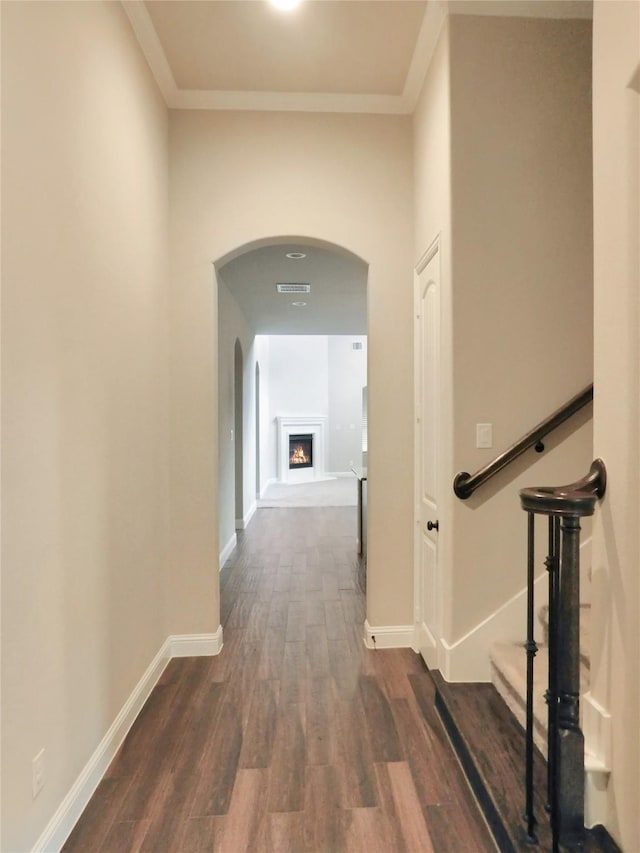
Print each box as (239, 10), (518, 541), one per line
(440, 572), (548, 682)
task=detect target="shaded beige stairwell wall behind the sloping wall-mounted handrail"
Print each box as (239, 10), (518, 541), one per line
(445, 16), (593, 641)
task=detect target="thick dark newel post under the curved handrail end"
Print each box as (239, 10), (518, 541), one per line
(557, 515), (585, 844)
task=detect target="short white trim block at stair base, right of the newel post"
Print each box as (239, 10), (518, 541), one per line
(580, 692), (613, 826)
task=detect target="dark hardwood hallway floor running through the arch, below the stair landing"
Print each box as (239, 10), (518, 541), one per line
(64, 507), (496, 853)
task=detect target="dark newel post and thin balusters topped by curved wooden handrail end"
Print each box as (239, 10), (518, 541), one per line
(520, 459), (607, 853)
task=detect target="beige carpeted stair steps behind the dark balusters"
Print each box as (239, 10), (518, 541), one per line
(490, 604), (591, 756)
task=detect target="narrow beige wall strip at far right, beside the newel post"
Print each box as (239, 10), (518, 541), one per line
(587, 0), (640, 851)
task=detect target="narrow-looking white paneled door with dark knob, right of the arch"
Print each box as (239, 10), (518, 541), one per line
(414, 243), (440, 668)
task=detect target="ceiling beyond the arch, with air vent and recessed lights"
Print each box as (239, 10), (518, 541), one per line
(218, 243), (367, 335)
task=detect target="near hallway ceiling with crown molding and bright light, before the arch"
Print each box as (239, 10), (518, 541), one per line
(122, 0), (592, 113)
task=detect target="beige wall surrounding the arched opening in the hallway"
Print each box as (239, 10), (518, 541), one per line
(170, 112), (413, 631)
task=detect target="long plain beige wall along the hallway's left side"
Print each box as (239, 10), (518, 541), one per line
(1, 3), (168, 851)
